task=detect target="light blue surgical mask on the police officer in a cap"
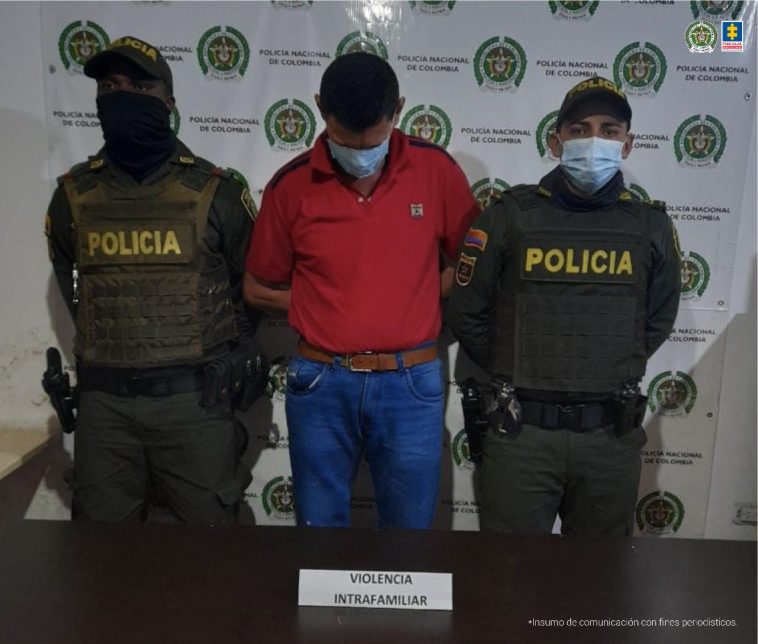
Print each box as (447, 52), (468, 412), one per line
(561, 136), (624, 194)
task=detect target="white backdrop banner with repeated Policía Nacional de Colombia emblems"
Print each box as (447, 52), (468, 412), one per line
(41, 0), (756, 537)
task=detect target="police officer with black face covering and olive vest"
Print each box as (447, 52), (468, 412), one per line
(46, 36), (256, 525)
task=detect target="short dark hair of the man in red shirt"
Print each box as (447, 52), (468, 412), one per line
(319, 52), (400, 132)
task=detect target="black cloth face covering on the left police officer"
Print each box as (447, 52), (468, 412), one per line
(96, 92), (176, 181)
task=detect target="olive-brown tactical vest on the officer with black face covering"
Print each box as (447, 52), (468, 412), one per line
(62, 157), (237, 368)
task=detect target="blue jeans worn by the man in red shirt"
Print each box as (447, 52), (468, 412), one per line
(285, 356), (445, 528)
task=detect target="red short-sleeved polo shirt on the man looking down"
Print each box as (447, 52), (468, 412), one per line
(245, 129), (478, 353)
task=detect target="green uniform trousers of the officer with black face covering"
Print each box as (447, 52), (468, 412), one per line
(72, 391), (251, 525)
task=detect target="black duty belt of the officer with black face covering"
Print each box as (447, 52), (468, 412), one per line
(77, 366), (204, 397)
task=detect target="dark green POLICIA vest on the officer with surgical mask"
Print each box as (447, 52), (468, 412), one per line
(491, 186), (652, 392)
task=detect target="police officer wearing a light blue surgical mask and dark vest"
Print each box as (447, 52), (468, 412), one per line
(448, 77), (680, 535)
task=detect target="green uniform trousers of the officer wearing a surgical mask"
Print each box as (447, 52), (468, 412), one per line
(480, 425), (647, 536)
